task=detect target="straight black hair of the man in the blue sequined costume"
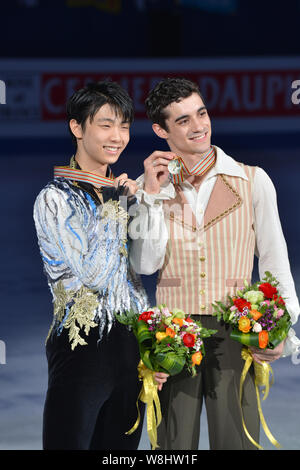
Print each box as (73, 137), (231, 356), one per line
(66, 80), (134, 144)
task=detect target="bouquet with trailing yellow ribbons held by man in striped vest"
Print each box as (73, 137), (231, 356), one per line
(212, 271), (291, 449)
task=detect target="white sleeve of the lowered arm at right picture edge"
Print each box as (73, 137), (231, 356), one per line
(253, 168), (300, 356)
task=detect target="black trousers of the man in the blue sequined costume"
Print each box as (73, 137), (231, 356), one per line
(43, 324), (144, 450)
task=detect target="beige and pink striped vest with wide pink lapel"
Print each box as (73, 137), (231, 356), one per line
(156, 164), (255, 315)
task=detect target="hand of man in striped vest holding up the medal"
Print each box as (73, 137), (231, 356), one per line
(144, 150), (177, 194)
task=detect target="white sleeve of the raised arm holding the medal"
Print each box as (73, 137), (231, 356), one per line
(128, 177), (175, 274)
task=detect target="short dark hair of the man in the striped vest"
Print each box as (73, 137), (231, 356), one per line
(145, 78), (204, 131)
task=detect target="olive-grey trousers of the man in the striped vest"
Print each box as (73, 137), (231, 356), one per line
(158, 315), (260, 450)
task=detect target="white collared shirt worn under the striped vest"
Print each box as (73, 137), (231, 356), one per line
(129, 146), (300, 356)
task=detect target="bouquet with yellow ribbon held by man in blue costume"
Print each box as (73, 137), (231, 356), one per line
(116, 305), (216, 449)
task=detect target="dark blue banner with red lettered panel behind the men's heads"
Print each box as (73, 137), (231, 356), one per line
(0, 57), (300, 137)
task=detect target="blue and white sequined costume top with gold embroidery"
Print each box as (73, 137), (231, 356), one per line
(34, 178), (148, 349)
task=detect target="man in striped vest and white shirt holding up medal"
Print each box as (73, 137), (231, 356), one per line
(130, 78), (300, 450)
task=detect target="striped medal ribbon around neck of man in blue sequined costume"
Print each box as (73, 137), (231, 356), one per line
(54, 166), (114, 188)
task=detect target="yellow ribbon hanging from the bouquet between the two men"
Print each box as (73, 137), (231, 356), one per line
(126, 360), (162, 450)
